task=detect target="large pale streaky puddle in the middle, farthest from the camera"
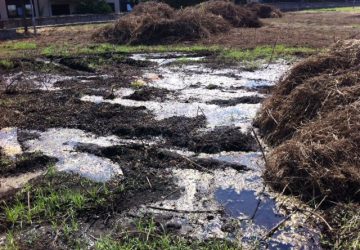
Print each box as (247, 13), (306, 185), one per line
(81, 54), (289, 130)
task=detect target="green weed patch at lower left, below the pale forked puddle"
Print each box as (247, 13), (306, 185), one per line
(0, 171), (115, 228)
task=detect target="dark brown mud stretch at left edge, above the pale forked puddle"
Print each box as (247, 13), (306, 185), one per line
(0, 90), (152, 135)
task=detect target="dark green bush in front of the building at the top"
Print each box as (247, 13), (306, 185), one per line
(76, 0), (112, 14)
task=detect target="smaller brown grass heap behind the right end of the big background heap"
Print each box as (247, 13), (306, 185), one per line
(200, 0), (261, 28)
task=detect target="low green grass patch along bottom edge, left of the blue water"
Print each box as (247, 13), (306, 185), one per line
(95, 219), (241, 250)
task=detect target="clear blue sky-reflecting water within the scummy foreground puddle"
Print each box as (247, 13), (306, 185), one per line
(215, 188), (283, 229)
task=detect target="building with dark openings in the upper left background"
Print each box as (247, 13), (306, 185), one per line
(0, 0), (123, 20)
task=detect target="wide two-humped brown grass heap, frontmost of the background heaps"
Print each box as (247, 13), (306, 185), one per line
(100, 8), (230, 44)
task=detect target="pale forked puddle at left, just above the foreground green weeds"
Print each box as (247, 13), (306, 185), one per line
(25, 129), (122, 182)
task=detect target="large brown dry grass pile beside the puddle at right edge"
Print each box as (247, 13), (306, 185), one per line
(255, 40), (360, 201)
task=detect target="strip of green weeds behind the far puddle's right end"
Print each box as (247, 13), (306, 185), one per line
(220, 45), (315, 62)
